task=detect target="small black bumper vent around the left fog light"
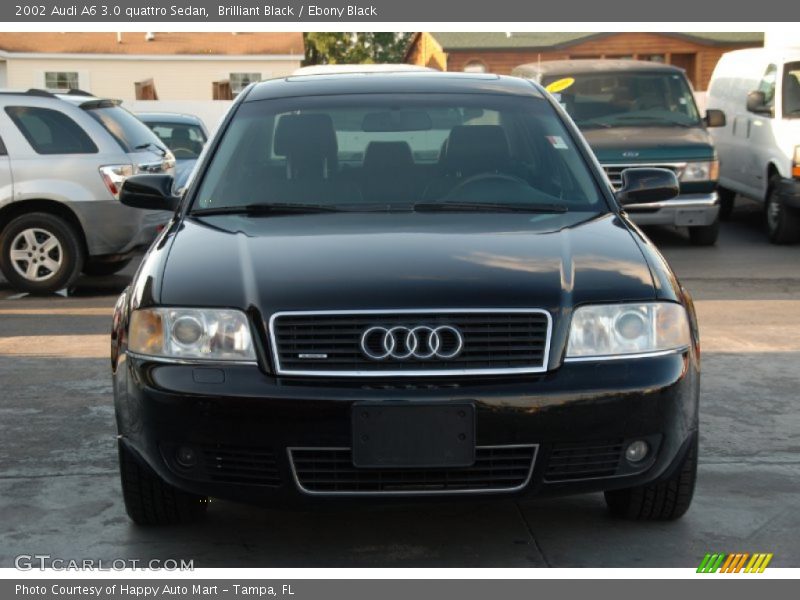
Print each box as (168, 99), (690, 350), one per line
(164, 444), (281, 486)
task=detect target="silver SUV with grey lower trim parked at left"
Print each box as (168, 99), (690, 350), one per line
(0, 90), (175, 293)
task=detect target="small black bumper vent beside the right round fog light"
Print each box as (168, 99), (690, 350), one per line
(545, 439), (623, 481)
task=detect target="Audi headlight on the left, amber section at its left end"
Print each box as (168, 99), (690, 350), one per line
(128, 308), (256, 362)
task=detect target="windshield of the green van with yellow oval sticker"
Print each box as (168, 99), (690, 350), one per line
(542, 72), (700, 129)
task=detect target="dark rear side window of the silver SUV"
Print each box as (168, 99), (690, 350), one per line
(6, 106), (97, 154)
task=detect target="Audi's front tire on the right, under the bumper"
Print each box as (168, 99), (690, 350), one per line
(604, 434), (697, 521)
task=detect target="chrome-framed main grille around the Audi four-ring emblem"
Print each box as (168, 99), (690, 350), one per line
(270, 309), (551, 377)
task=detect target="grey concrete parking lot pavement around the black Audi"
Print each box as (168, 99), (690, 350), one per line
(0, 200), (800, 567)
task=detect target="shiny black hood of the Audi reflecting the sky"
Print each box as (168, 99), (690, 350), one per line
(155, 213), (655, 315)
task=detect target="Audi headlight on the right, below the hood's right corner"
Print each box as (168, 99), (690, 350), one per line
(567, 302), (691, 359)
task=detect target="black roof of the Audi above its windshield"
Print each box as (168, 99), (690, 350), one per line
(244, 71), (543, 102)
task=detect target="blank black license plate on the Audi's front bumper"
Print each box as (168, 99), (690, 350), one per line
(352, 403), (475, 468)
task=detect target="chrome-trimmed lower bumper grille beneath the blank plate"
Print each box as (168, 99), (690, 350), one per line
(289, 445), (537, 495)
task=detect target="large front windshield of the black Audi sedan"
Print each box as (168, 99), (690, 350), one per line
(192, 94), (606, 212)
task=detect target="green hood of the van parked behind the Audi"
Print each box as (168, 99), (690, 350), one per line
(582, 127), (714, 163)
